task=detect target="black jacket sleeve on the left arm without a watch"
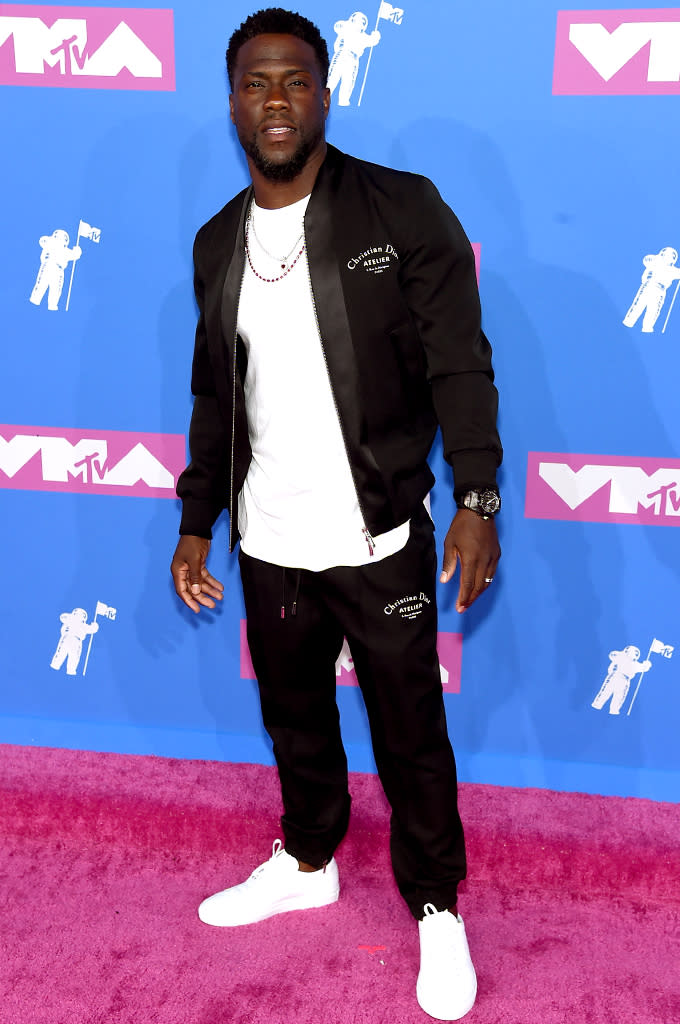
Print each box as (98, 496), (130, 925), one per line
(177, 231), (229, 539)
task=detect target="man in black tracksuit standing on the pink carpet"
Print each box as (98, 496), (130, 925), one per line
(172, 8), (501, 1020)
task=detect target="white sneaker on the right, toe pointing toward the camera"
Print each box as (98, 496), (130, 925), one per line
(416, 903), (477, 1021)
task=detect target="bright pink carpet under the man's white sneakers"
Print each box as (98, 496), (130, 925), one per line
(0, 745), (680, 1024)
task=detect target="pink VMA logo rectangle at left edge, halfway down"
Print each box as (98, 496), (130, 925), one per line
(0, 425), (186, 498)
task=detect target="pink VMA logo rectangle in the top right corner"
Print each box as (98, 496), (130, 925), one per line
(553, 7), (680, 96)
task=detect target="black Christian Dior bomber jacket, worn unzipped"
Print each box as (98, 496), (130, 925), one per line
(177, 145), (502, 548)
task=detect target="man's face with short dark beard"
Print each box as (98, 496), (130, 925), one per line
(229, 35), (330, 181)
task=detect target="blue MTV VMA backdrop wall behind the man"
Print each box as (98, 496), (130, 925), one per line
(0, 0), (680, 800)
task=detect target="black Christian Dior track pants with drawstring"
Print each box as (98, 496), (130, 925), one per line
(239, 509), (466, 919)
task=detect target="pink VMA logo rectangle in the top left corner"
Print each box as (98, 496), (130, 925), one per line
(0, 3), (175, 90)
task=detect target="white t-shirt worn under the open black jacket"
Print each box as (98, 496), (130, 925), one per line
(238, 196), (409, 571)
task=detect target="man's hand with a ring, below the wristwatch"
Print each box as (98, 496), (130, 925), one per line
(439, 509), (501, 611)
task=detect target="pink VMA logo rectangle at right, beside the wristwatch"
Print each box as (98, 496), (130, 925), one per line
(524, 452), (680, 526)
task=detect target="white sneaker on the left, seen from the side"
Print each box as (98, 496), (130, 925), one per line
(199, 839), (340, 928)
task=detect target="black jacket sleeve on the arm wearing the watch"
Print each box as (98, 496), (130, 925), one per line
(399, 178), (503, 495)
